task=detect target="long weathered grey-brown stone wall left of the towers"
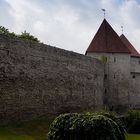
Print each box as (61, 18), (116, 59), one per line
(0, 35), (104, 120)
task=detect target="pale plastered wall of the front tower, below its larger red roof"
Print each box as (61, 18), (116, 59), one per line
(86, 53), (130, 110)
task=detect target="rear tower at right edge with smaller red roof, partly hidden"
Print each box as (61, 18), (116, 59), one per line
(120, 34), (140, 108)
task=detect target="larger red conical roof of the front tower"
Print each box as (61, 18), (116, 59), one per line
(86, 19), (130, 53)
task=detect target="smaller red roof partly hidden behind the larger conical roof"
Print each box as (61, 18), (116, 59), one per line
(120, 34), (140, 57)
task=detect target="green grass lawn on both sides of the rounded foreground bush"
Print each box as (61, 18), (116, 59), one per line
(0, 119), (140, 140)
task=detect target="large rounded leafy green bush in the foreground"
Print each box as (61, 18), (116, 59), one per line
(48, 113), (125, 140)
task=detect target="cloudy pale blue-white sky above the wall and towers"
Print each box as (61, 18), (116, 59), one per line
(0, 0), (140, 54)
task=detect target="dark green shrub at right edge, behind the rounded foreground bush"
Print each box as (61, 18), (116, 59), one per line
(124, 110), (140, 134)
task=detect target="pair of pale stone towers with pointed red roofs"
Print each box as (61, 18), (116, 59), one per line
(85, 19), (140, 110)
